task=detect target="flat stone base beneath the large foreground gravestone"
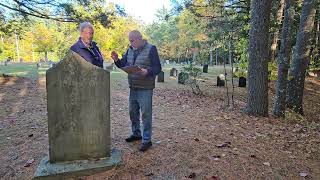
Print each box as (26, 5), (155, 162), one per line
(33, 149), (122, 180)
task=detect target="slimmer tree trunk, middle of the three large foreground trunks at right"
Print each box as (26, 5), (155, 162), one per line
(273, 0), (294, 117)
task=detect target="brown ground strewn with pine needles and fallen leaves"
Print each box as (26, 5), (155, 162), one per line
(0, 73), (320, 180)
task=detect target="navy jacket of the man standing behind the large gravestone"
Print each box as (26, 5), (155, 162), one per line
(70, 38), (103, 68)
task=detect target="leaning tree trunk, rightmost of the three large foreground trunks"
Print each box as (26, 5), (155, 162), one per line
(287, 0), (316, 114)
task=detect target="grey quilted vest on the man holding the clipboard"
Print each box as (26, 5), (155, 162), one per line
(127, 42), (155, 89)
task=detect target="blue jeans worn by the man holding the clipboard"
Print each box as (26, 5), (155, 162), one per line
(129, 89), (153, 143)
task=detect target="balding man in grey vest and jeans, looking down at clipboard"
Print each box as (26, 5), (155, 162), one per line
(111, 30), (161, 152)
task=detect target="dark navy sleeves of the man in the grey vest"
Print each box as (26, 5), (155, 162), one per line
(115, 46), (162, 76)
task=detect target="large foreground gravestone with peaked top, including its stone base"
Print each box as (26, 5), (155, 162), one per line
(35, 51), (121, 179)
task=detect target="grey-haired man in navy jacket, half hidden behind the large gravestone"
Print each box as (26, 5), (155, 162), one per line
(70, 22), (103, 68)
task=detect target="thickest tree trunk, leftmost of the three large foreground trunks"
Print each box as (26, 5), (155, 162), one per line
(246, 0), (272, 116)
